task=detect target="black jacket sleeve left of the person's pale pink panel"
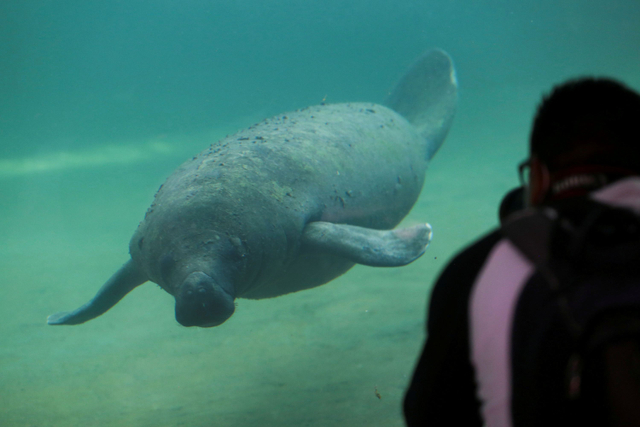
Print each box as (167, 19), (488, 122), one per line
(404, 230), (502, 427)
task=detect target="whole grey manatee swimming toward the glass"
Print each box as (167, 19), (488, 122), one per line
(48, 50), (457, 327)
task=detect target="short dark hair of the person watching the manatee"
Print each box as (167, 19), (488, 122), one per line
(531, 78), (640, 173)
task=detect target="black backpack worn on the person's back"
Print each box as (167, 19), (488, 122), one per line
(501, 198), (640, 427)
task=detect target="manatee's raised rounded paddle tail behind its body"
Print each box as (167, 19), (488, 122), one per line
(386, 49), (458, 159)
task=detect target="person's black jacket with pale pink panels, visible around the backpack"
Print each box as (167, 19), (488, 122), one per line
(404, 178), (640, 427)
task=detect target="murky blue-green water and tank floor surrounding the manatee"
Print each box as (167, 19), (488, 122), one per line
(0, 0), (640, 427)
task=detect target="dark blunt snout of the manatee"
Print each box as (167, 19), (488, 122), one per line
(175, 271), (235, 328)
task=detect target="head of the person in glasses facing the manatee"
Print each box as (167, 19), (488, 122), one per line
(529, 78), (640, 205)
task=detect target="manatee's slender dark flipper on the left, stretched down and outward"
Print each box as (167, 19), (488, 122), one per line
(47, 260), (148, 325)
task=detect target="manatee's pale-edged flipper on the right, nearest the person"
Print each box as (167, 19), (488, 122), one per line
(302, 221), (432, 267)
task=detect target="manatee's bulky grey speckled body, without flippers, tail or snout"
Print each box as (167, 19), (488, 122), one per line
(130, 104), (427, 298)
